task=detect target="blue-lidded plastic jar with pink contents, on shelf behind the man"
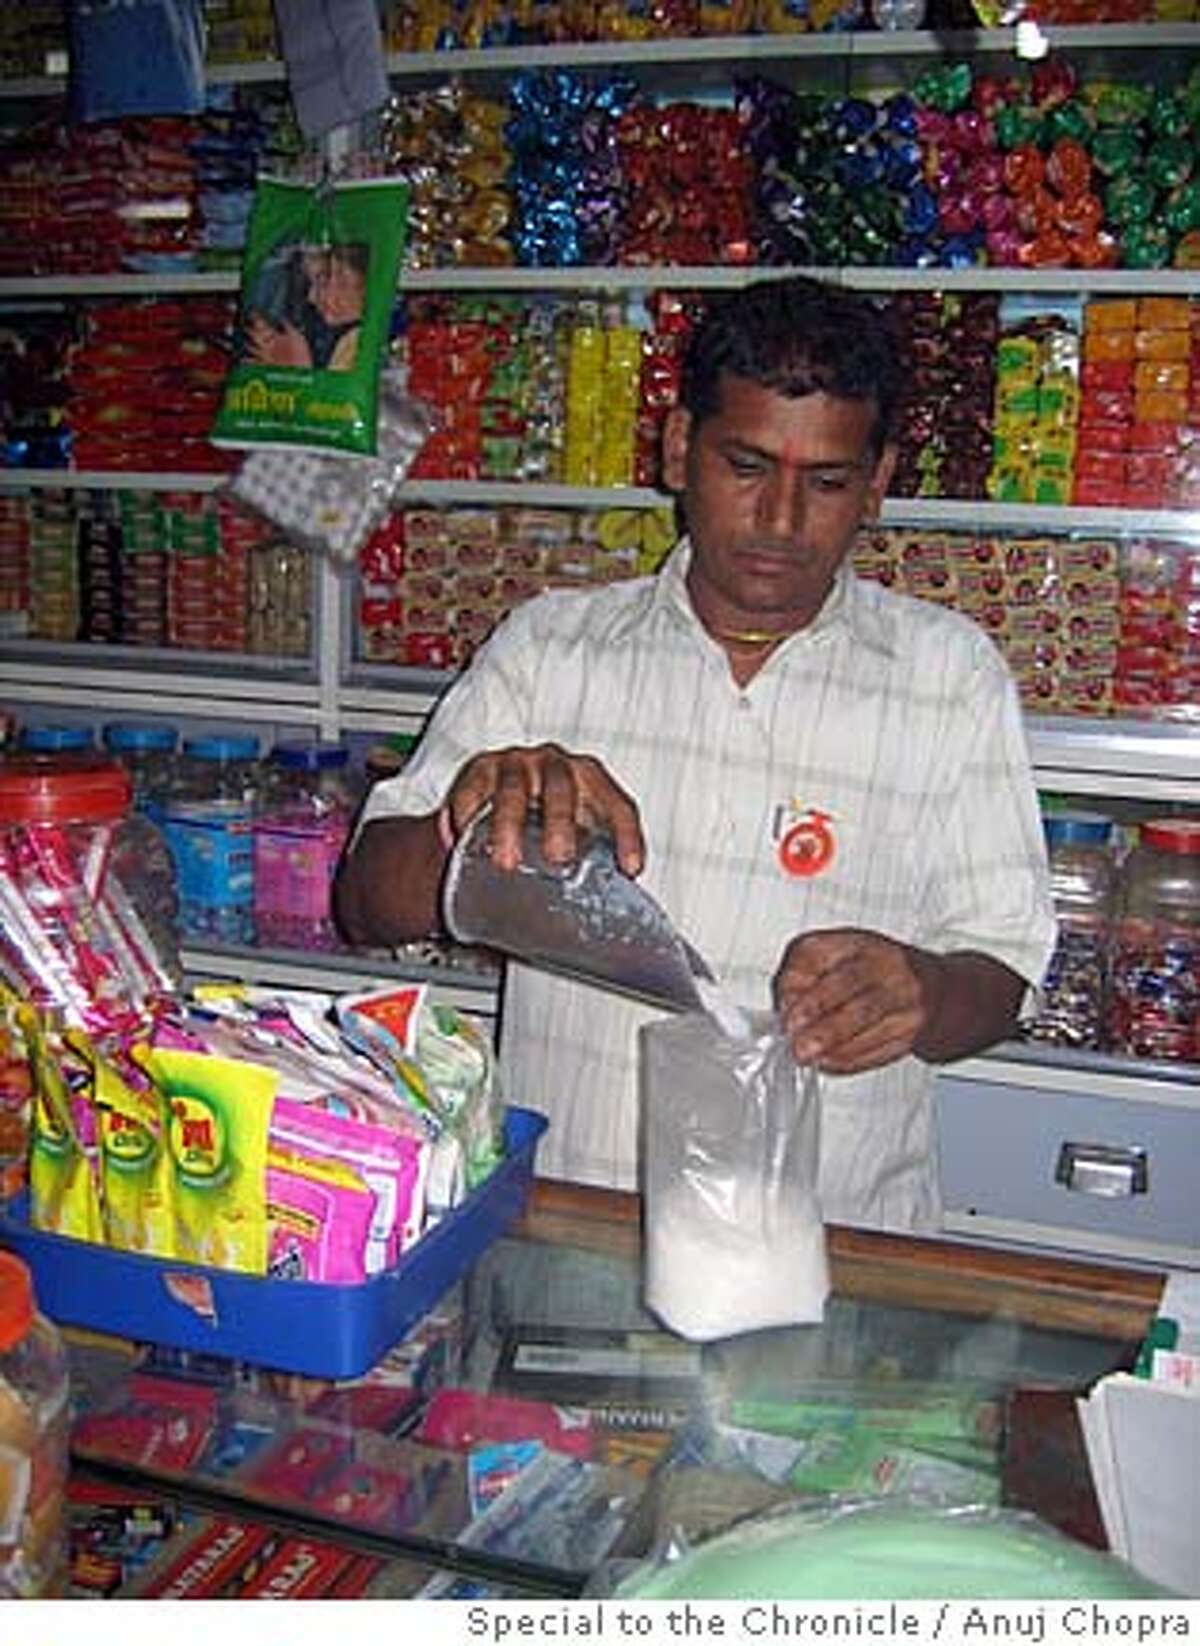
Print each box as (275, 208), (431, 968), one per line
(253, 742), (357, 950)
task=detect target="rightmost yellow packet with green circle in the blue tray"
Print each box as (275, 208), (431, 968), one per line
(138, 1047), (278, 1274)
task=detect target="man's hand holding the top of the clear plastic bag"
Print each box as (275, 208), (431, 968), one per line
(775, 928), (933, 1075)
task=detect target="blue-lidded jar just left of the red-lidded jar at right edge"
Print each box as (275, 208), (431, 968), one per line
(1026, 811), (1118, 1050)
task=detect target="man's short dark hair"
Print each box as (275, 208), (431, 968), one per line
(683, 275), (904, 454)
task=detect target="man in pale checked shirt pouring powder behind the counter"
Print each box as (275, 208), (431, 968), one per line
(337, 278), (1053, 1230)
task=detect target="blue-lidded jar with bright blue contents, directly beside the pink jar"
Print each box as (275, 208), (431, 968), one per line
(166, 736), (262, 943)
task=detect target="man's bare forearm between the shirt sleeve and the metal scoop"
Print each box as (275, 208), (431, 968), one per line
(334, 813), (446, 946)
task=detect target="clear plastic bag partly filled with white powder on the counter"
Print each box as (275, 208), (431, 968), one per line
(639, 1014), (830, 1341)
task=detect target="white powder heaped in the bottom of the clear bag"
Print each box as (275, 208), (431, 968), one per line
(645, 1179), (830, 1341)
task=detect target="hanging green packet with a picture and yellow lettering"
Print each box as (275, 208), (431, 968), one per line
(212, 178), (408, 456)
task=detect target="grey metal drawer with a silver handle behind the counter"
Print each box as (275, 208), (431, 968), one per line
(935, 1057), (1200, 1267)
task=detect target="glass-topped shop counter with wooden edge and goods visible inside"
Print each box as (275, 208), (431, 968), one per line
(58, 1182), (1162, 1597)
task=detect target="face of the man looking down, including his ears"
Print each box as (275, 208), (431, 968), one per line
(663, 374), (895, 629)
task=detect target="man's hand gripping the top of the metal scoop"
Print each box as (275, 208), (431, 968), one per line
(444, 742), (645, 874)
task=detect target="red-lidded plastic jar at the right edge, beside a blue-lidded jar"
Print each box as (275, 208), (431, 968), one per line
(1108, 818), (1200, 1062)
